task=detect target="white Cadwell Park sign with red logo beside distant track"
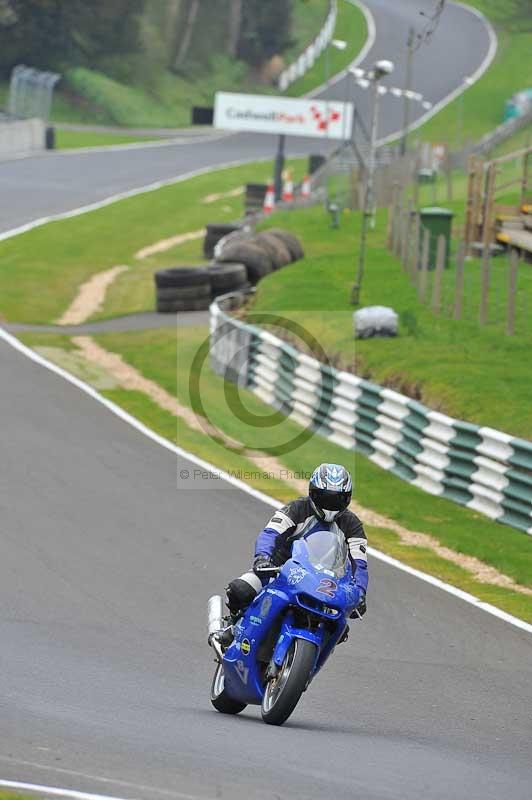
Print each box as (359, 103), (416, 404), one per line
(214, 92), (353, 139)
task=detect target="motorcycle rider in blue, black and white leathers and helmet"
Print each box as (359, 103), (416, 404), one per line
(227, 464), (368, 618)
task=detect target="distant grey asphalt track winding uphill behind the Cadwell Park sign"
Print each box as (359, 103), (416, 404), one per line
(0, 0), (491, 232)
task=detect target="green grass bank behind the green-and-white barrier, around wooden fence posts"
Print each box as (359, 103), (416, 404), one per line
(253, 201), (532, 438)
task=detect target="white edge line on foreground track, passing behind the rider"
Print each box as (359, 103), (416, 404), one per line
(0, 328), (532, 633)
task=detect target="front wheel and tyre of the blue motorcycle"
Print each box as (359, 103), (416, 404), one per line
(261, 639), (316, 725)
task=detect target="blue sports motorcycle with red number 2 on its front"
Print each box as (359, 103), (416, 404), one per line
(209, 526), (360, 725)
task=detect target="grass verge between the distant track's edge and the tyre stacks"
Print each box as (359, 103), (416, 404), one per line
(0, 160), (306, 323)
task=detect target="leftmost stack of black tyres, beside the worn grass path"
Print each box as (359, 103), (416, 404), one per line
(155, 267), (211, 314)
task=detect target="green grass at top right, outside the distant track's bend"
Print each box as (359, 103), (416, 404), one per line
(414, 0), (532, 149)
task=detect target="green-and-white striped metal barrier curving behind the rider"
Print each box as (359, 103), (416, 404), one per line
(210, 295), (532, 534)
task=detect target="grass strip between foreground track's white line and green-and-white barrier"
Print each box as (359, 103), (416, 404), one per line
(18, 328), (532, 621)
